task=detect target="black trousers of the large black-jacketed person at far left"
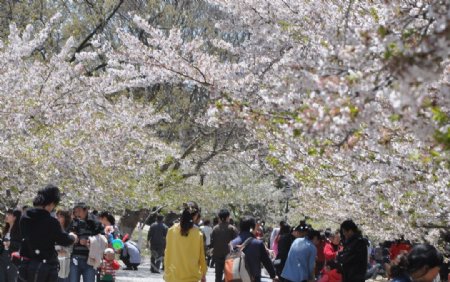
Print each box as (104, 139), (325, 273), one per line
(17, 260), (58, 282)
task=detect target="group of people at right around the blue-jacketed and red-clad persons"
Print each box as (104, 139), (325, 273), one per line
(271, 220), (447, 282)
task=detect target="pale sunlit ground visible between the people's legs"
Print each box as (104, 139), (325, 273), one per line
(116, 257), (272, 282)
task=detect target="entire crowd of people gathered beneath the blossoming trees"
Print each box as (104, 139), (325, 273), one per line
(0, 185), (448, 282)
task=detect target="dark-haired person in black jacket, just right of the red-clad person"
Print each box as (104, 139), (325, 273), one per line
(337, 220), (367, 282)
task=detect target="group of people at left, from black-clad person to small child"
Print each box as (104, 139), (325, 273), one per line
(0, 185), (141, 282)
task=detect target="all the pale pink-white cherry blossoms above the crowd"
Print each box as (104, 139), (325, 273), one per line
(0, 0), (450, 242)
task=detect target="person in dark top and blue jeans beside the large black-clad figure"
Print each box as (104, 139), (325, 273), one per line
(69, 202), (104, 282)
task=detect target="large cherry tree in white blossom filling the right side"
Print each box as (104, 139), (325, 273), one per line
(106, 0), (449, 241)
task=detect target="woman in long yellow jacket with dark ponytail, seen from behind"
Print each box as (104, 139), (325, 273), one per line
(164, 202), (207, 282)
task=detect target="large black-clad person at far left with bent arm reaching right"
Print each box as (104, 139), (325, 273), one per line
(19, 185), (77, 282)
